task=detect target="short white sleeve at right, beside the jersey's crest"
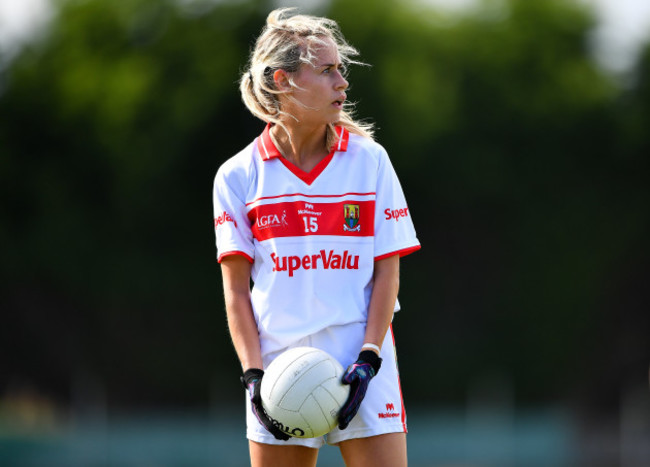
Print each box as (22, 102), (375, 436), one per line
(374, 148), (420, 261)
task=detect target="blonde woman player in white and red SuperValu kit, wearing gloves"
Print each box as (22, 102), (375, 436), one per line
(213, 9), (420, 467)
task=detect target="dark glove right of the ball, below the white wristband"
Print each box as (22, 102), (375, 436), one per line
(339, 350), (381, 430)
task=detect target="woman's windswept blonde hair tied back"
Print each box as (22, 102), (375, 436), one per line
(239, 8), (373, 147)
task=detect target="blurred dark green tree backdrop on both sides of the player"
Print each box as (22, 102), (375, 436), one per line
(0, 0), (650, 405)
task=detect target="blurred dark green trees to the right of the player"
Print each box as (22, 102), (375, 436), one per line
(332, 0), (649, 403)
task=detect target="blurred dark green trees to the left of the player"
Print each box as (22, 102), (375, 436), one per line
(0, 0), (269, 403)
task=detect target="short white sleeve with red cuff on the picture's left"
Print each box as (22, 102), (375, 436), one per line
(212, 165), (255, 263)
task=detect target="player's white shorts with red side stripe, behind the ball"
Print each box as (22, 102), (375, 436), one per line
(246, 323), (407, 448)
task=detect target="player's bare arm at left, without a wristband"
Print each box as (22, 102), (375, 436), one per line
(221, 255), (263, 371)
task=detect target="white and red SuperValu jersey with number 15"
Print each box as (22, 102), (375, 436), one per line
(213, 125), (420, 355)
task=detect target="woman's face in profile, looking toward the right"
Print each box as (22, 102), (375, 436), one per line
(283, 38), (349, 125)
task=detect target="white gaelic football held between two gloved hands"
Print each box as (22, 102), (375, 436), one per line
(261, 347), (350, 438)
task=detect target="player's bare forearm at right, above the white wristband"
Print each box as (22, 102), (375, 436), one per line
(363, 255), (399, 356)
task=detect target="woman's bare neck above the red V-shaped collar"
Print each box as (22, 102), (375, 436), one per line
(271, 122), (329, 172)
